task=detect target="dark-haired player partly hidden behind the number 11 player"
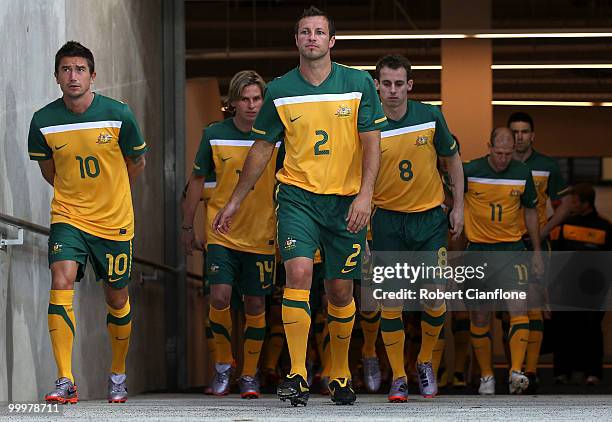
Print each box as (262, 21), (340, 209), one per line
(508, 112), (569, 394)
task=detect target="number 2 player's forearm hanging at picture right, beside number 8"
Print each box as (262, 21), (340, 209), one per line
(346, 130), (380, 233)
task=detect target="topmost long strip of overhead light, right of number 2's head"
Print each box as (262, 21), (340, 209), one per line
(336, 28), (612, 40)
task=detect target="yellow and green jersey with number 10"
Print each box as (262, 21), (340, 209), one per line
(28, 94), (147, 241)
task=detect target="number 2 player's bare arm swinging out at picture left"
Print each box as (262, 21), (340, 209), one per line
(212, 141), (275, 234)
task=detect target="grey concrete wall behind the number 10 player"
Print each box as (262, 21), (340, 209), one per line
(0, 0), (166, 402)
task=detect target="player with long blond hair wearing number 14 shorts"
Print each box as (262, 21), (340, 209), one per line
(183, 70), (279, 398)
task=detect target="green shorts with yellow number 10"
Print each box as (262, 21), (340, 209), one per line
(49, 223), (132, 289)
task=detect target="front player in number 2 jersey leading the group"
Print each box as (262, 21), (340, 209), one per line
(214, 7), (387, 405)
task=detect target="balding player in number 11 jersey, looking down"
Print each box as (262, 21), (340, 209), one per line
(464, 127), (543, 394)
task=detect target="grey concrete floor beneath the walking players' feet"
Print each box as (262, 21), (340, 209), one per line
(0, 394), (612, 422)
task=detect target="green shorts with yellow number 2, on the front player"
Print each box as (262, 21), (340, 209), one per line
(276, 183), (366, 280)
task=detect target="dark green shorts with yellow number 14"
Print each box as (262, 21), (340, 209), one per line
(206, 245), (275, 296)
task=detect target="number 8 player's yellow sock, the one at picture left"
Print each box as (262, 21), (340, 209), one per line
(380, 307), (406, 380)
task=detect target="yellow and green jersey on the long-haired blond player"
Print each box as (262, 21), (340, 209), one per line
(193, 118), (280, 254)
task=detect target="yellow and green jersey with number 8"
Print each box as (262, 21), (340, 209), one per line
(373, 101), (457, 212)
